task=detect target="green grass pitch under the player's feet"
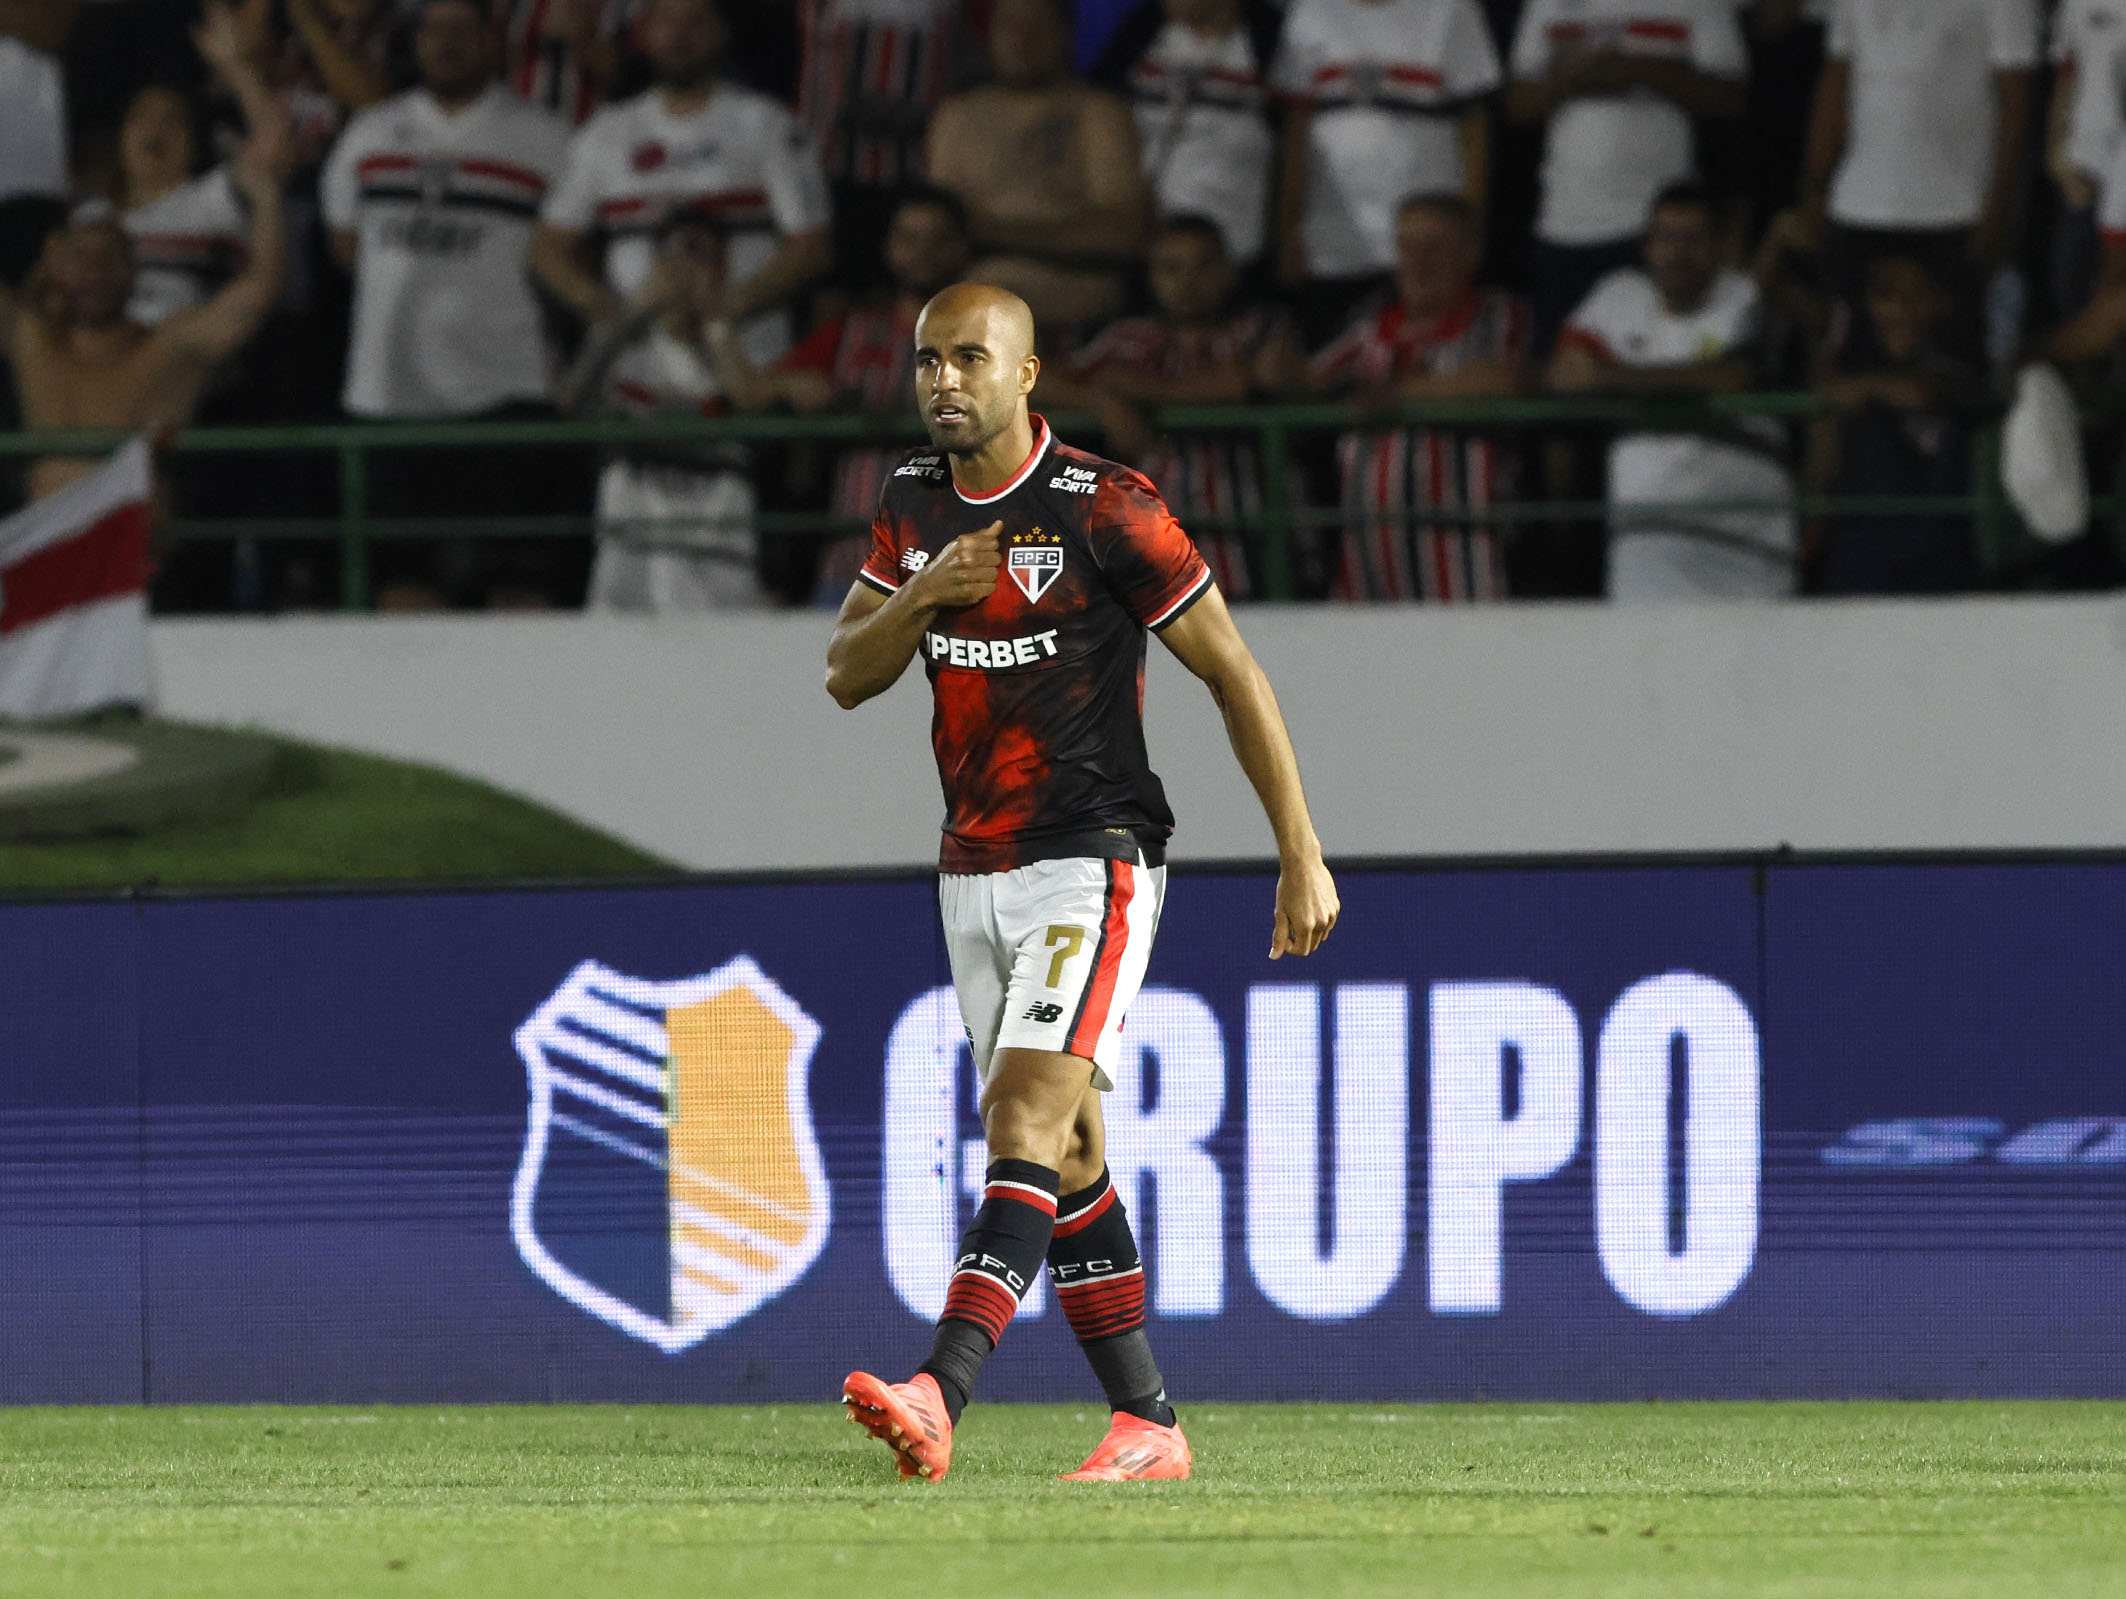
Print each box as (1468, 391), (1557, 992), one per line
(0, 1403), (2126, 1599)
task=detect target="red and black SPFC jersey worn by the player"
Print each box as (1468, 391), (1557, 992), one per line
(859, 417), (1212, 872)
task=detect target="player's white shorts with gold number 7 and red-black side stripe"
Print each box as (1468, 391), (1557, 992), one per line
(938, 857), (1167, 1091)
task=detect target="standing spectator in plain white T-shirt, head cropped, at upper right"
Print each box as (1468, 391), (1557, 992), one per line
(1803, 0), (2039, 342)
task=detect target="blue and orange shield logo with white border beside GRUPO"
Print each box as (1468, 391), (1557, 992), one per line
(510, 955), (829, 1354)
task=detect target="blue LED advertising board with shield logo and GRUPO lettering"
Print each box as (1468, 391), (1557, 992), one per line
(0, 859), (2126, 1403)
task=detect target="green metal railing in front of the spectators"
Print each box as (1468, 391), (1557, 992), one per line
(0, 393), (2074, 610)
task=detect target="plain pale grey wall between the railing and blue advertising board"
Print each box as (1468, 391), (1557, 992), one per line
(153, 597), (2126, 870)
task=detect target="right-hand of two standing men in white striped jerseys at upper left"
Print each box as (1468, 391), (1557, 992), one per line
(532, 0), (831, 366)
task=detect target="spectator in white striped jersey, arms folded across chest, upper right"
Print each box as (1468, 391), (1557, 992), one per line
(1505, 0), (1750, 353)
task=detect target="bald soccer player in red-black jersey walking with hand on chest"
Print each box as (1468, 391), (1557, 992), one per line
(827, 283), (1337, 1482)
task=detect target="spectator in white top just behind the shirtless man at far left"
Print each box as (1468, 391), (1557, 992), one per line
(111, 0), (274, 327)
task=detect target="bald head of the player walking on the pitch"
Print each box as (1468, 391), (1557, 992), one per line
(916, 283), (1042, 455)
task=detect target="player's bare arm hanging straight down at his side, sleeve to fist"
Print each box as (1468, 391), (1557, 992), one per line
(1159, 589), (1339, 961)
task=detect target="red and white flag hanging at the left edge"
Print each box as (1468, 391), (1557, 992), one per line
(0, 438), (155, 721)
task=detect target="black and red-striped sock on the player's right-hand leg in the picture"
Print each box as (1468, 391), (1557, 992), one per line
(1048, 1172), (1174, 1427)
